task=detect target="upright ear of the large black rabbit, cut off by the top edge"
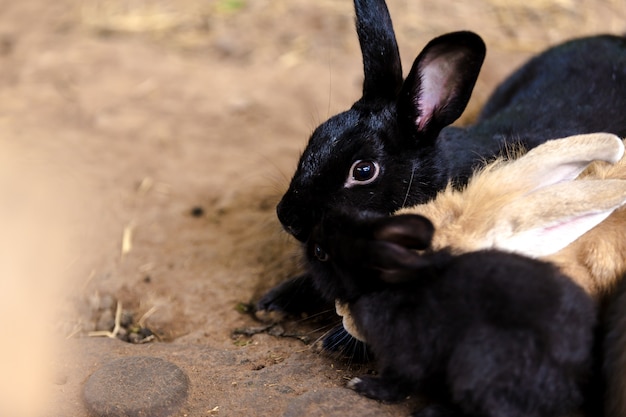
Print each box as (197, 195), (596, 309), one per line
(354, 0), (402, 100)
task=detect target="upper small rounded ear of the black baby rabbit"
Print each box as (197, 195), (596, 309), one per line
(374, 214), (435, 249)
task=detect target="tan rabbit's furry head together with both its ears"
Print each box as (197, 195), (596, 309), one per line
(397, 133), (626, 256)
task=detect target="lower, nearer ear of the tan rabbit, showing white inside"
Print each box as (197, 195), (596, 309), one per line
(486, 179), (626, 257)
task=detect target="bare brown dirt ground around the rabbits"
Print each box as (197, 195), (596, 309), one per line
(0, 0), (626, 416)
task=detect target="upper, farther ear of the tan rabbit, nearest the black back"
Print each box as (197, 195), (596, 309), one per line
(505, 133), (624, 189)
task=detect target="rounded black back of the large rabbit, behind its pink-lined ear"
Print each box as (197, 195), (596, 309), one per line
(470, 35), (626, 148)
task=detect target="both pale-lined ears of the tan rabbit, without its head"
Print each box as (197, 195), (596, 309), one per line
(478, 133), (626, 257)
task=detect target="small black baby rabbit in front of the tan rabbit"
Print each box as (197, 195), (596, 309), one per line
(307, 213), (595, 417)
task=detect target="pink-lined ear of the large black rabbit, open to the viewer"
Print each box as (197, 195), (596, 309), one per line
(398, 32), (486, 139)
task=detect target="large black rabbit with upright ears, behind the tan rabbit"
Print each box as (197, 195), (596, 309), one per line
(257, 0), (626, 350)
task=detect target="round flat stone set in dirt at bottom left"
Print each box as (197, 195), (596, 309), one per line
(83, 356), (189, 417)
